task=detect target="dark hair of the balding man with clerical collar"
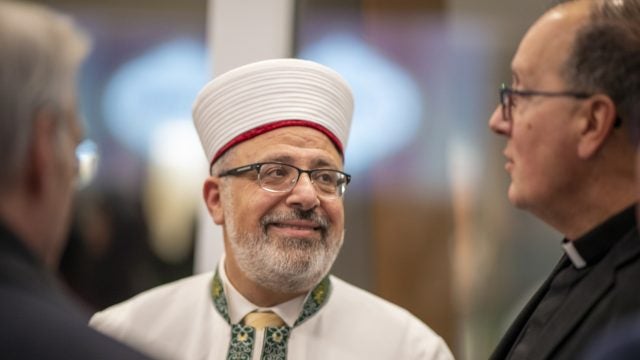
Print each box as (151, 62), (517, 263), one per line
(565, 0), (640, 134)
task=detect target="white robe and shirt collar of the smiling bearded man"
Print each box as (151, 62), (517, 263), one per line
(90, 262), (453, 360)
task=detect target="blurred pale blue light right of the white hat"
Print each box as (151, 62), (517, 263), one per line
(298, 33), (423, 174)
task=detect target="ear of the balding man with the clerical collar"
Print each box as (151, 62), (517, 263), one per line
(578, 94), (617, 159)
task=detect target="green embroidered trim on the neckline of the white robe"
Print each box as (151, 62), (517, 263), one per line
(211, 269), (331, 360)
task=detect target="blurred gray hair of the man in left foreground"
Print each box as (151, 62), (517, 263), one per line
(0, 0), (90, 189)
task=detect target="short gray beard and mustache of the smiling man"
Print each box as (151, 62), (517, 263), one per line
(225, 205), (344, 293)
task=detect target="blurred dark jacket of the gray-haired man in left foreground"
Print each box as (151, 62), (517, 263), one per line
(0, 224), (147, 360)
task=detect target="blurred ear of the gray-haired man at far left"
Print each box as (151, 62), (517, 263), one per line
(24, 110), (57, 196)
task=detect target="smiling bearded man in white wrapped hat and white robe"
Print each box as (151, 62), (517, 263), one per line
(91, 59), (452, 359)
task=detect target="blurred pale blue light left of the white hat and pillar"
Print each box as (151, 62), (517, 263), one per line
(102, 38), (208, 157)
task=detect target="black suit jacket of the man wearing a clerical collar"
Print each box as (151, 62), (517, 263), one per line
(491, 210), (640, 359)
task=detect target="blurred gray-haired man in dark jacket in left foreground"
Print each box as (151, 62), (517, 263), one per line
(0, 1), (146, 360)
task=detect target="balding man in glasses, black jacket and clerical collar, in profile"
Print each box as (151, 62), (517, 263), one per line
(489, 0), (640, 359)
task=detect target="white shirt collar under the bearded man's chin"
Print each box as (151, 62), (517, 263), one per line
(218, 254), (306, 327)
